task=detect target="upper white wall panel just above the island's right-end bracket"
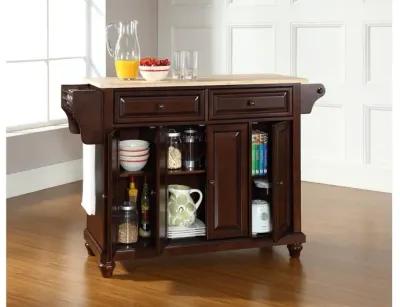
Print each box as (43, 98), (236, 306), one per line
(292, 24), (346, 84)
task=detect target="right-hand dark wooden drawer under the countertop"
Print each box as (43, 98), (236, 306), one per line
(209, 87), (292, 119)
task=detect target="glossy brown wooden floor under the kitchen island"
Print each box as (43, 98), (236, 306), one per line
(7, 183), (391, 307)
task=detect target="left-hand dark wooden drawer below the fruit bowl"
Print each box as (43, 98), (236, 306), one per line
(115, 90), (205, 123)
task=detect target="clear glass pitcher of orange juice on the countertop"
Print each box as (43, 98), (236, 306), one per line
(106, 20), (140, 80)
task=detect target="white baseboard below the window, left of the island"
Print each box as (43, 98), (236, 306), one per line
(7, 159), (82, 198)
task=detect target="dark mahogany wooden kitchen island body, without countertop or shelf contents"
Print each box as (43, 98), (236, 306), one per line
(61, 83), (325, 277)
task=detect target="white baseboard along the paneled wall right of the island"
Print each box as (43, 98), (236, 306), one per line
(301, 160), (392, 193)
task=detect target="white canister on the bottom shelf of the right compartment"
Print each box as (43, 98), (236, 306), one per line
(251, 199), (272, 235)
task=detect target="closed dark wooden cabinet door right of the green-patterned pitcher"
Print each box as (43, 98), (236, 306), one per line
(207, 124), (249, 239)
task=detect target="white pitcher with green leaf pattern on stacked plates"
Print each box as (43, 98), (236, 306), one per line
(168, 184), (203, 227)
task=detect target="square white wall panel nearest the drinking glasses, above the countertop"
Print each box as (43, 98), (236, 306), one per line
(230, 25), (276, 74)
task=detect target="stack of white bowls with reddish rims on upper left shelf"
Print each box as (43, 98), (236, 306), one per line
(119, 140), (150, 172)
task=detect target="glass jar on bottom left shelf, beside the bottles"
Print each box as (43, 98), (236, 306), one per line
(118, 202), (138, 244)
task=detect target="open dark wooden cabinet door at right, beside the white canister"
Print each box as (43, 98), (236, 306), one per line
(272, 122), (292, 241)
